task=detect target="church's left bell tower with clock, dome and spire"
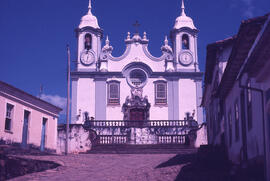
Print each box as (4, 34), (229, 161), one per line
(76, 0), (103, 71)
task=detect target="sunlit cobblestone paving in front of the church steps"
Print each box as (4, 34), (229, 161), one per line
(13, 154), (188, 181)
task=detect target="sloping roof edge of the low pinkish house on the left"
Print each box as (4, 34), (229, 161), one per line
(0, 81), (62, 114)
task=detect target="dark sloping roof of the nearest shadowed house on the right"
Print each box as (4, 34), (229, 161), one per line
(217, 15), (268, 98)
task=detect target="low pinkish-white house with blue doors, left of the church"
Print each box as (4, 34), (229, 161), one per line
(0, 81), (62, 151)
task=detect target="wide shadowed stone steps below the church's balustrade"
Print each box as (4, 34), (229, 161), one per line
(87, 144), (197, 154)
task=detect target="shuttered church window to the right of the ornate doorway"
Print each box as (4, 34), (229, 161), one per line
(155, 81), (167, 105)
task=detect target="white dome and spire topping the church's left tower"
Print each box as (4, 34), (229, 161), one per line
(79, 0), (100, 29)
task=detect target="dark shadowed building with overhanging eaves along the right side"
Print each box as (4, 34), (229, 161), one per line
(202, 14), (270, 180)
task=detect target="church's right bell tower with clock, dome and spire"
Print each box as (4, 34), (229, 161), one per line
(171, 0), (199, 72)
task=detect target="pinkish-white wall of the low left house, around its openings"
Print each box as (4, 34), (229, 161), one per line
(0, 94), (58, 150)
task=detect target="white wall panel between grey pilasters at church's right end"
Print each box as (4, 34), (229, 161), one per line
(179, 79), (197, 120)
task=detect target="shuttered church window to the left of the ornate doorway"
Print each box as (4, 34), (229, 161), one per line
(108, 81), (120, 105)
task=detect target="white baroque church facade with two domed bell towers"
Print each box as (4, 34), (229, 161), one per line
(71, 0), (203, 124)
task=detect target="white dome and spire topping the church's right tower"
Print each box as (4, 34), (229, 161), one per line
(174, 0), (196, 29)
